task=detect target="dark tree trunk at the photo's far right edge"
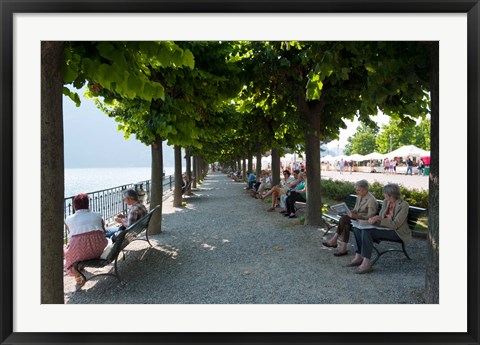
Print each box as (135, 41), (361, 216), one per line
(425, 42), (439, 304)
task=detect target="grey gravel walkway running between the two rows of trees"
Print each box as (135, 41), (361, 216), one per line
(65, 173), (427, 304)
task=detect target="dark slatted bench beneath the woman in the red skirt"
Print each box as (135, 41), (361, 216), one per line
(73, 205), (160, 288)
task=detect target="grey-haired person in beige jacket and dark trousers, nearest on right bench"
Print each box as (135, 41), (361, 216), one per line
(348, 183), (412, 274)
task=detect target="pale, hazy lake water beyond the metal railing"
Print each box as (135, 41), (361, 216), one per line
(65, 167), (175, 197)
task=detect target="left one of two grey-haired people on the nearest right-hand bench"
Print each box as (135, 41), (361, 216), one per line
(322, 180), (377, 256)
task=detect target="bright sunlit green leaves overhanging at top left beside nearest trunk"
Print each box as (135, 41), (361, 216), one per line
(63, 41), (194, 106)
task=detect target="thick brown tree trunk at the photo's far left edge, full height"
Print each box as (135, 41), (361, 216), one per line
(40, 41), (64, 304)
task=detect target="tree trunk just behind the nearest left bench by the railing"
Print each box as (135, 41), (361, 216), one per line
(148, 138), (163, 235)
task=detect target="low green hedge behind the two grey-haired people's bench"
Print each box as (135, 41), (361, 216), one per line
(321, 179), (428, 208)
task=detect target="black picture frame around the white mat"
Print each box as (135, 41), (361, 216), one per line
(0, 0), (480, 344)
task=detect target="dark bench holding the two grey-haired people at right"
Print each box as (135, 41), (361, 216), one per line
(322, 194), (427, 265)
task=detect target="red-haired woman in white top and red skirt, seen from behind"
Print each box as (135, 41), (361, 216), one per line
(63, 194), (108, 285)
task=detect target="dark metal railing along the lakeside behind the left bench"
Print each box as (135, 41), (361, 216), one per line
(63, 175), (175, 244)
